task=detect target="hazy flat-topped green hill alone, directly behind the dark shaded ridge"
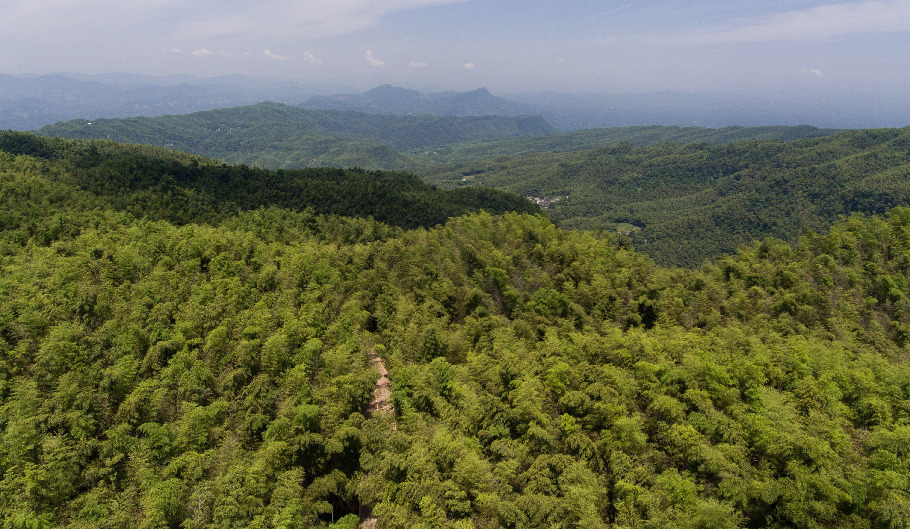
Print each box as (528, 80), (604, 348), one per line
(39, 103), (552, 169)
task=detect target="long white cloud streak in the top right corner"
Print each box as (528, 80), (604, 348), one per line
(684, 0), (910, 44)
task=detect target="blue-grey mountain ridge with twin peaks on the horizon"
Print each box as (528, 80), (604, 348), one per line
(300, 84), (538, 116)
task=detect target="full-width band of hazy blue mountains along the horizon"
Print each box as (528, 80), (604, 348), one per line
(0, 74), (910, 132)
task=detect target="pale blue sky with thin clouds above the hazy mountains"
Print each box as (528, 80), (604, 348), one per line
(0, 0), (910, 100)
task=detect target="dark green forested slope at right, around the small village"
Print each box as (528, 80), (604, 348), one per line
(422, 128), (910, 266)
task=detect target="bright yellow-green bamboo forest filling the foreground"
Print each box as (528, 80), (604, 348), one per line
(0, 135), (910, 529)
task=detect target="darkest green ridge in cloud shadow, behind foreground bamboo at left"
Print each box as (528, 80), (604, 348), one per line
(0, 133), (533, 228)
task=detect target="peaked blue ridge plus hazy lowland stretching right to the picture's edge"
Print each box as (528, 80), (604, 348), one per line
(301, 85), (910, 132)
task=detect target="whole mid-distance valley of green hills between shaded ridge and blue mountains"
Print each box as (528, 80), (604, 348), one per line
(38, 104), (910, 267)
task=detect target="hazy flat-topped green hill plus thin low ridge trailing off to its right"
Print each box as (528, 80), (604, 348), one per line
(38, 103), (836, 172)
